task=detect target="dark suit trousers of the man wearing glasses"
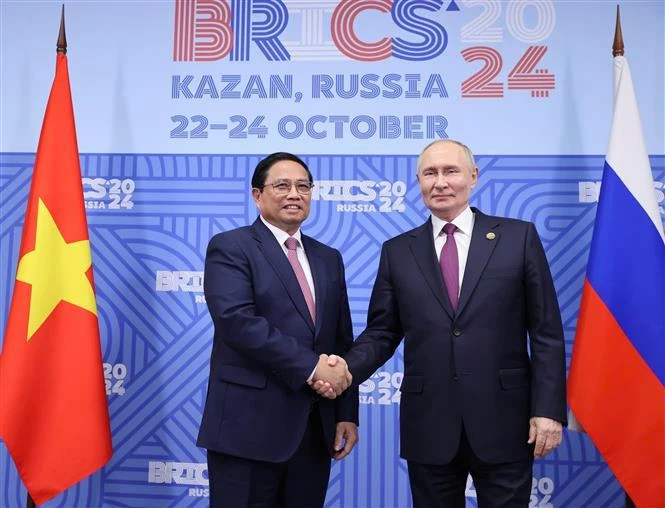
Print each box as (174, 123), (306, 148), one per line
(208, 407), (331, 508)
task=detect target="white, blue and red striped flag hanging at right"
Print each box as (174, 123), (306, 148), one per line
(568, 56), (665, 507)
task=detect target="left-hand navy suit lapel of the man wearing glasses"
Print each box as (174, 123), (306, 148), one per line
(252, 218), (318, 331)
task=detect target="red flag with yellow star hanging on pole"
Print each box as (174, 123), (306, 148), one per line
(0, 54), (112, 504)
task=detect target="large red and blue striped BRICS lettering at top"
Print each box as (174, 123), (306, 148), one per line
(173, 0), (459, 62)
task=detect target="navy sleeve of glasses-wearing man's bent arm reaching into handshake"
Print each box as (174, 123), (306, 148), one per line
(204, 235), (318, 391)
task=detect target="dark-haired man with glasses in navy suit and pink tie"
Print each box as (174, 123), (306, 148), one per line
(197, 152), (358, 508)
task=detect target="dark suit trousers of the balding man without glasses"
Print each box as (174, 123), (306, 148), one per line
(409, 426), (533, 508)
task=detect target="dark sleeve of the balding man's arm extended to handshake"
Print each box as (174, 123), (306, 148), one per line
(345, 244), (404, 385)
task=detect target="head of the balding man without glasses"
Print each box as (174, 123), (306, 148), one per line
(418, 142), (478, 222)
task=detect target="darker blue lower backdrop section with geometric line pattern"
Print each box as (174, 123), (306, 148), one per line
(0, 153), (665, 507)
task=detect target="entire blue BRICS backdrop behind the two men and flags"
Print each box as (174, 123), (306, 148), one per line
(0, 0), (665, 508)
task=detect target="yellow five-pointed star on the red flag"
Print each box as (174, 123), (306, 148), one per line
(16, 199), (97, 340)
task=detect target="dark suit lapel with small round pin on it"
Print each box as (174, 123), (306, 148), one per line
(457, 208), (501, 315)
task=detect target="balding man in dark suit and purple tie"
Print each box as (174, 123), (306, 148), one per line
(315, 140), (566, 508)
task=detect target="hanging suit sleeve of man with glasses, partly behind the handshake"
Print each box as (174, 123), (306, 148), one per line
(335, 252), (359, 425)
